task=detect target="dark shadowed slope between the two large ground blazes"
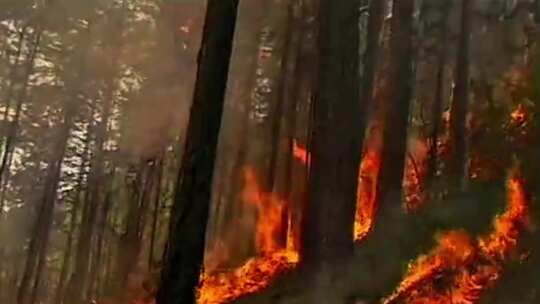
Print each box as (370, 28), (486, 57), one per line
(234, 186), (505, 304)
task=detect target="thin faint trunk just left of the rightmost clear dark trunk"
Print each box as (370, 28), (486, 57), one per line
(426, 4), (450, 185)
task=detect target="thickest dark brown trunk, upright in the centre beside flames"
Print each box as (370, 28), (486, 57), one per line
(301, 0), (364, 266)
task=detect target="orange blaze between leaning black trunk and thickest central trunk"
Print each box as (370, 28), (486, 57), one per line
(198, 167), (299, 304)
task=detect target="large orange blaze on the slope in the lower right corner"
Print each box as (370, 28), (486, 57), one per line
(384, 172), (529, 304)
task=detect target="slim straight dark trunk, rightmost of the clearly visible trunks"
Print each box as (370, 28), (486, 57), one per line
(448, 0), (474, 188)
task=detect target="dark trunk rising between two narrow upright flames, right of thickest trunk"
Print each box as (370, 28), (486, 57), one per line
(376, 0), (415, 208)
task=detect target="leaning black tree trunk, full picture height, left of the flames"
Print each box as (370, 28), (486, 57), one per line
(156, 0), (238, 304)
